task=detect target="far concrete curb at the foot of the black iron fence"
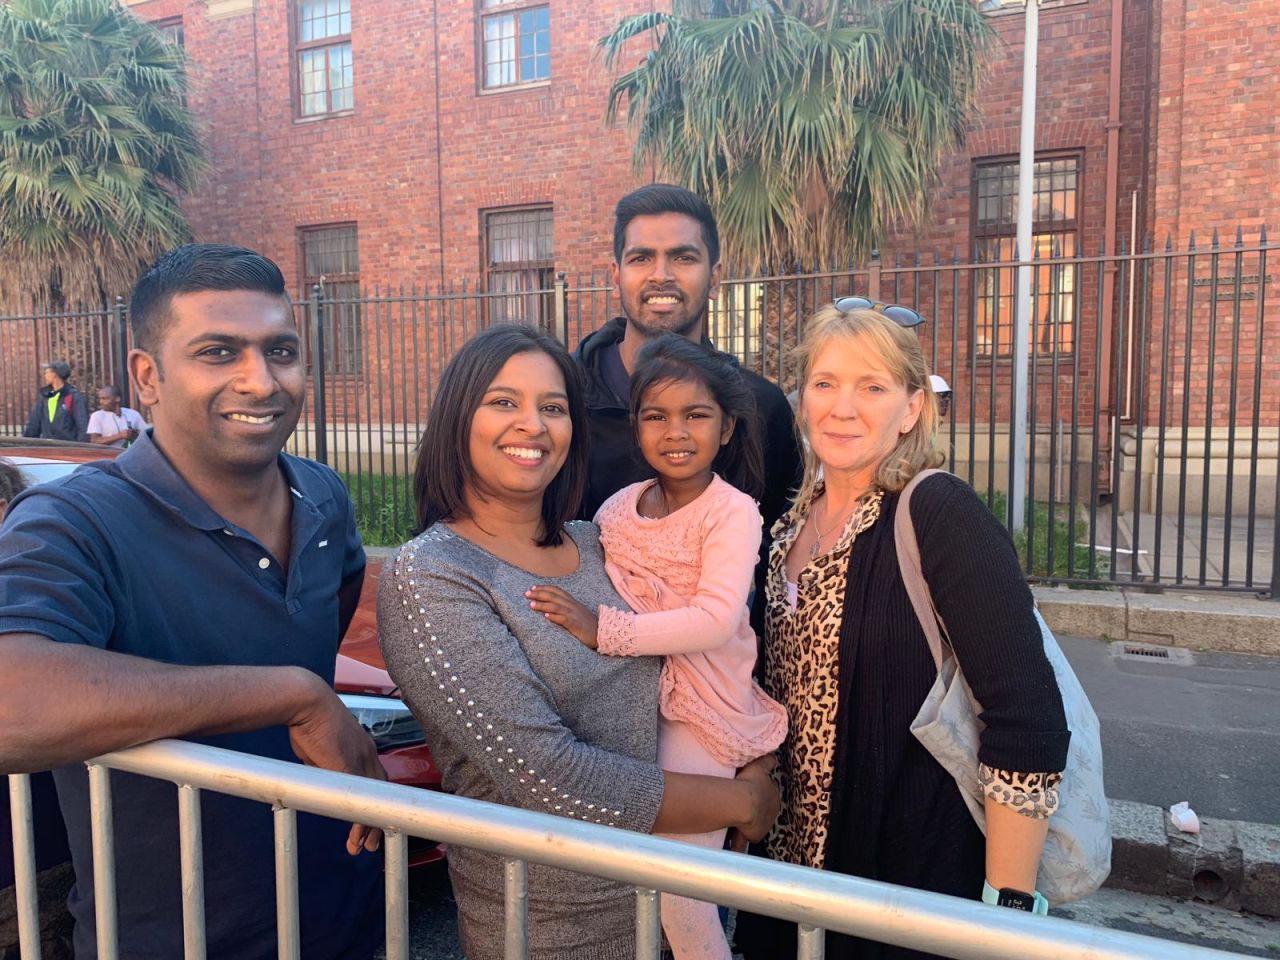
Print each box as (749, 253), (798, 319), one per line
(1032, 586), (1280, 657)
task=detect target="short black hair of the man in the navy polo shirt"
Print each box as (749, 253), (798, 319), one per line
(129, 243), (288, 355)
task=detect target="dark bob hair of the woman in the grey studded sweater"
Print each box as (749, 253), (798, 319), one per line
(413, 324), (588, 547)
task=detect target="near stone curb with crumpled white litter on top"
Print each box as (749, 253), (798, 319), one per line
(1106, 800), (1280, 916)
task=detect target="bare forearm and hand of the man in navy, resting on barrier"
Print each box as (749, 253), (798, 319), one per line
(0, 634), (387, 850)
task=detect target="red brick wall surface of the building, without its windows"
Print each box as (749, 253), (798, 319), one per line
(117, 0), (1280, 432)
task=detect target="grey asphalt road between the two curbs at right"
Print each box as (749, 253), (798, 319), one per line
(1061, 637), (1280, 823)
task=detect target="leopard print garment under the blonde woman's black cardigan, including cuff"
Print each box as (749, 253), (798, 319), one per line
(764, 484), (1061, 869)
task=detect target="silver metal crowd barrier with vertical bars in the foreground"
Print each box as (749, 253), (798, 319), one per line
(9, 741), (1233, 960)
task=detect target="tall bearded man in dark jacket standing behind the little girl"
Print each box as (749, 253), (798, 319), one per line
(576, 183), (801, 630)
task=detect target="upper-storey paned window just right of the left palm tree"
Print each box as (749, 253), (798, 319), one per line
(294, 0), (356, 116)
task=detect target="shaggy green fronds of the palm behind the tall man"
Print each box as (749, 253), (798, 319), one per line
(600, 0), (992, 270)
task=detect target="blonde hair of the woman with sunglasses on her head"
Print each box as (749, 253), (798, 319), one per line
(795, 306), (945, 503)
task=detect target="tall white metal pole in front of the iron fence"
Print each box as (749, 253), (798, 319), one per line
(1009, 0), (1039, 530)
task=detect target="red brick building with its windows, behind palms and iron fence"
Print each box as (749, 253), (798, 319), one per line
(115, 0), (1280, 514)
